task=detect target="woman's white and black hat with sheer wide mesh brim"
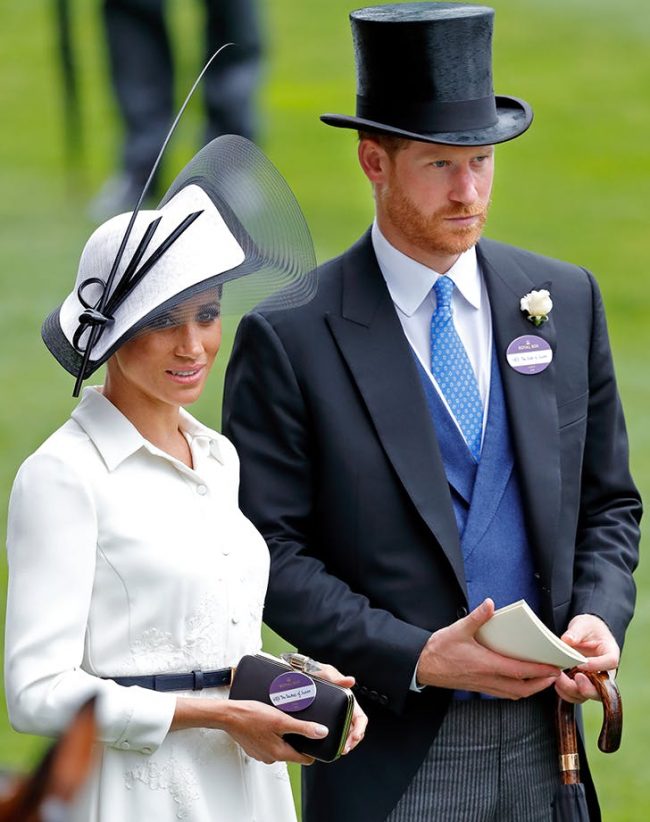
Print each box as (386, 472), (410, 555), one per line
(42, 135), (316, 395)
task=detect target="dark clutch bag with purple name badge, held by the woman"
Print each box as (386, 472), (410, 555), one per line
(230, 653), (354, 762)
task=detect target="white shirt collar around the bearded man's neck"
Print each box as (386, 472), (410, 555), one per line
(372, 220), (481, 317)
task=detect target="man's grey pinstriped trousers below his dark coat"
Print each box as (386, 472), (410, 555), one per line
(386, 696), (559, 822)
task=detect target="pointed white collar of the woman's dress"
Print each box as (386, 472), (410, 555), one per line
(71, 386), (223, 471)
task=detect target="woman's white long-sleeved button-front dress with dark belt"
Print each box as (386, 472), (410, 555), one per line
(5, 388), (295, 822)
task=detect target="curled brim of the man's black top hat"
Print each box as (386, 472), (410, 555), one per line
(320, 97), (533, 146)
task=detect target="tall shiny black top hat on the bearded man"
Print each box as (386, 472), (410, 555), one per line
(321, 3), (533, 146)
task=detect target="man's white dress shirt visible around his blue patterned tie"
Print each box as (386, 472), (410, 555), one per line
(372, 221), (492, 433)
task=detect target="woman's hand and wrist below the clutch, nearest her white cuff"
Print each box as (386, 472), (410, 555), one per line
(171, 697), (328, 765)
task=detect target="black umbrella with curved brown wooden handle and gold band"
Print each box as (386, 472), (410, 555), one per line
(552, 668), (623, 822)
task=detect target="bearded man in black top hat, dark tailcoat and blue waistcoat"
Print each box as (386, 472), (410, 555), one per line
(224, 3), (641, 822)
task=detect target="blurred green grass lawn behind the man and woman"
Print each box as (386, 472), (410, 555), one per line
(0, 0), (650, 822)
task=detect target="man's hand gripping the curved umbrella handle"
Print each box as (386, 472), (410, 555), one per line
(555, 614), (621, 703)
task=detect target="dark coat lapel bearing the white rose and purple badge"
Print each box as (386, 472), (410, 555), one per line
(477, 241), (561, 588)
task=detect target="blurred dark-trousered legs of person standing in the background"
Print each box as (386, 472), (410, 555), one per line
(89, 0), (263, 221)
